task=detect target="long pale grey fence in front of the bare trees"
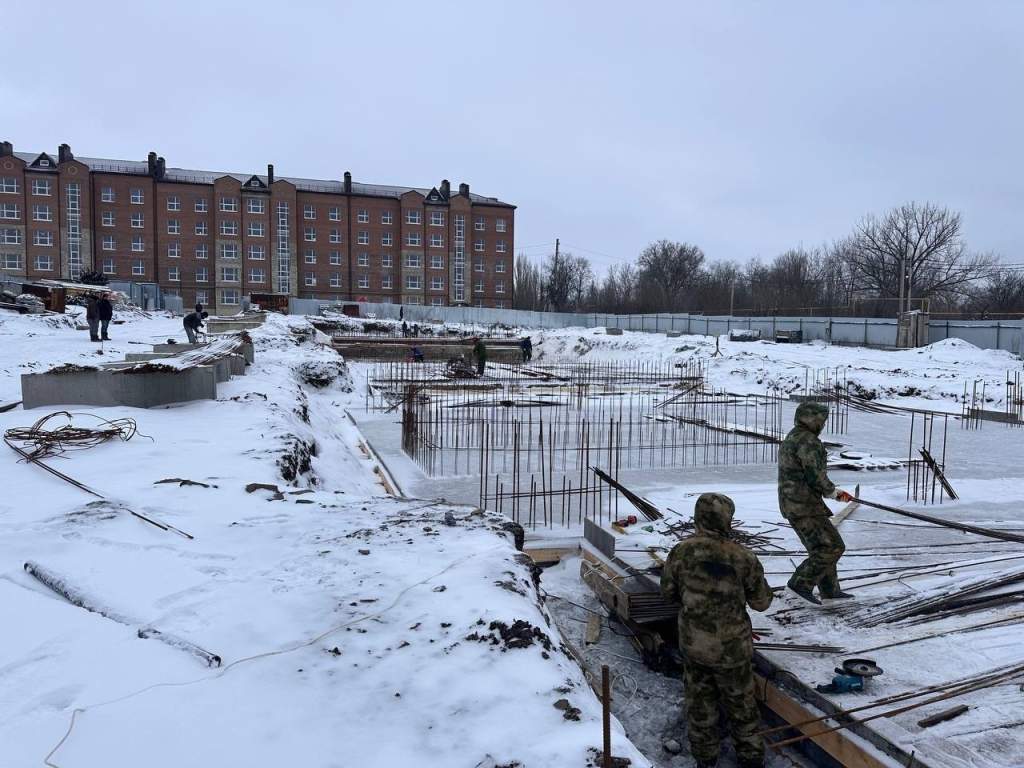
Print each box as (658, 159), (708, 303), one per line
(289, 299), (1024, 354)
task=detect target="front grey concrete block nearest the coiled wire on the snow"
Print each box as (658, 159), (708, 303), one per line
(22, 364), (217, 410)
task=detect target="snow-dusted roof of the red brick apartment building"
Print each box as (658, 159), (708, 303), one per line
(14, 152), (515, 208)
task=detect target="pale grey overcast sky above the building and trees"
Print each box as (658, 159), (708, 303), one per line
(0, 0), (1024, 274)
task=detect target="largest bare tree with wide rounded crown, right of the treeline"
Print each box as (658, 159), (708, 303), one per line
(846, 203), (992, 313)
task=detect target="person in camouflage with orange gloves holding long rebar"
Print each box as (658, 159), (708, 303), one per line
(778, 402), (853, 604)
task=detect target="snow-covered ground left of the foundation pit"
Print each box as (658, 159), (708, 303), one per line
(0, 314), (648, 768)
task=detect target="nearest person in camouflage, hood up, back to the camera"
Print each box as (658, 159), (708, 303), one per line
(662, 494), (772, 768)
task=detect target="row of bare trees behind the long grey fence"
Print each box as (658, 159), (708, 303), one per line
(515, 203), (1024, 316)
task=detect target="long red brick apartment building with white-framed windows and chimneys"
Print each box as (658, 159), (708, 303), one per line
(0, 141), (515, 313)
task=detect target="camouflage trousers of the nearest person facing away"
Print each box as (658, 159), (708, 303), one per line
(683, 659), (765, 763)
